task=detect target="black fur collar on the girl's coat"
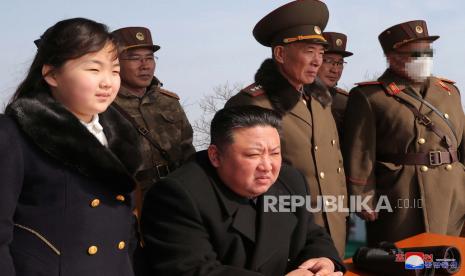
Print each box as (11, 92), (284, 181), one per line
(6, 93), (141, 193)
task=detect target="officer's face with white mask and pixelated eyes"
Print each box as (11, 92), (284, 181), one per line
(387, 40), (433, 81)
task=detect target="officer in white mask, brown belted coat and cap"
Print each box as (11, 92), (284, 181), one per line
(343, 20), (465, 244)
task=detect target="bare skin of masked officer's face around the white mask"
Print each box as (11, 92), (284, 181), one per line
(387, 40), (433, 79)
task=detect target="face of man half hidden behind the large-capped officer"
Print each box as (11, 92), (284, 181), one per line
(318, 54), (344, 87)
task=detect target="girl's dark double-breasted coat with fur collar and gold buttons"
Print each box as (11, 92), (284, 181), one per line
(0, 93), (140, 276)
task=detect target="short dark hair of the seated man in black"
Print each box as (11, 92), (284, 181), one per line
(210, 105), (281, 148)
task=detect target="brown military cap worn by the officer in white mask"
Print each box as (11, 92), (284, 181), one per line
(378, 20), (439, 53)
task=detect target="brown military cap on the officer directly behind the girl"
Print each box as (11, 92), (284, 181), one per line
(113, 27), (160, 52)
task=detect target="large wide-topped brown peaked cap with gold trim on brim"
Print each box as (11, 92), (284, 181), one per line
(253, 0), (329, 47)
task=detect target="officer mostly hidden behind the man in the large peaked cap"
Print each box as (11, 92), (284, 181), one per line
(318, 32), (353, 136)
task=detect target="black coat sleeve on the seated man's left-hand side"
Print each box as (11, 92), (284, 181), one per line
(141, 178), (262, 276)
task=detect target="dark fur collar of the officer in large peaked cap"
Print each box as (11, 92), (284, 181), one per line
(255, 59), (332, 113)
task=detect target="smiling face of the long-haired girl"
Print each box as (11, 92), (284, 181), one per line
(42, 43), (120, 122)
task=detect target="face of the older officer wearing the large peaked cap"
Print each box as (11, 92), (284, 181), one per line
(273, 42), (324, 90)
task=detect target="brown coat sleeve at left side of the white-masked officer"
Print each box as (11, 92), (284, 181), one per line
(342, 88), (376, 209)
